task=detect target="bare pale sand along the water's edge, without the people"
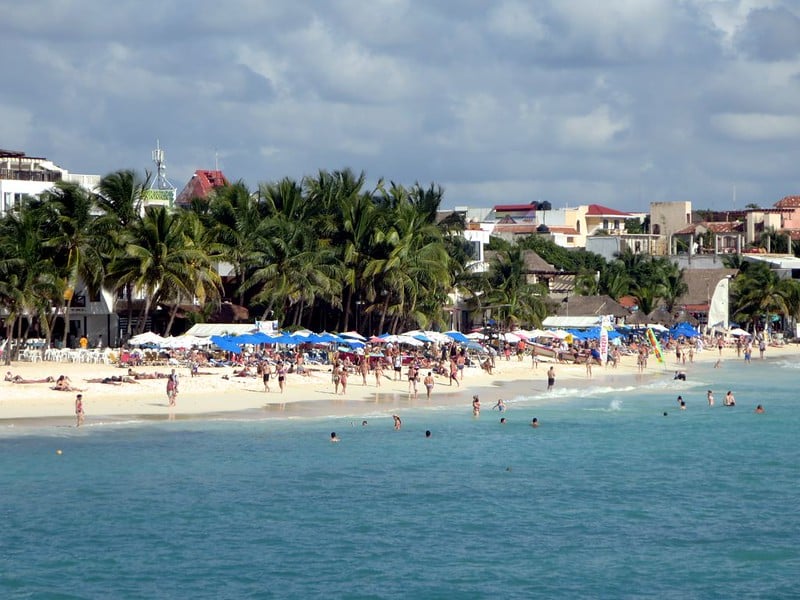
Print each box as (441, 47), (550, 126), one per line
(0, 345), (800, 430)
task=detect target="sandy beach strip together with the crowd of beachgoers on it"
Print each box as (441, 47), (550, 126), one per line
(0, 330), (795, 421)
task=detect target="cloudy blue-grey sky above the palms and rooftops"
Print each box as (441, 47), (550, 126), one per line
(0, 0), (800, 211)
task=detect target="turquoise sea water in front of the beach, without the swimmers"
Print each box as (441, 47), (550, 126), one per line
(0, 361), (800, 598)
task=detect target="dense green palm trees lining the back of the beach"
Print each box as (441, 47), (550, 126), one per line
(0, 170), (800, 356)
